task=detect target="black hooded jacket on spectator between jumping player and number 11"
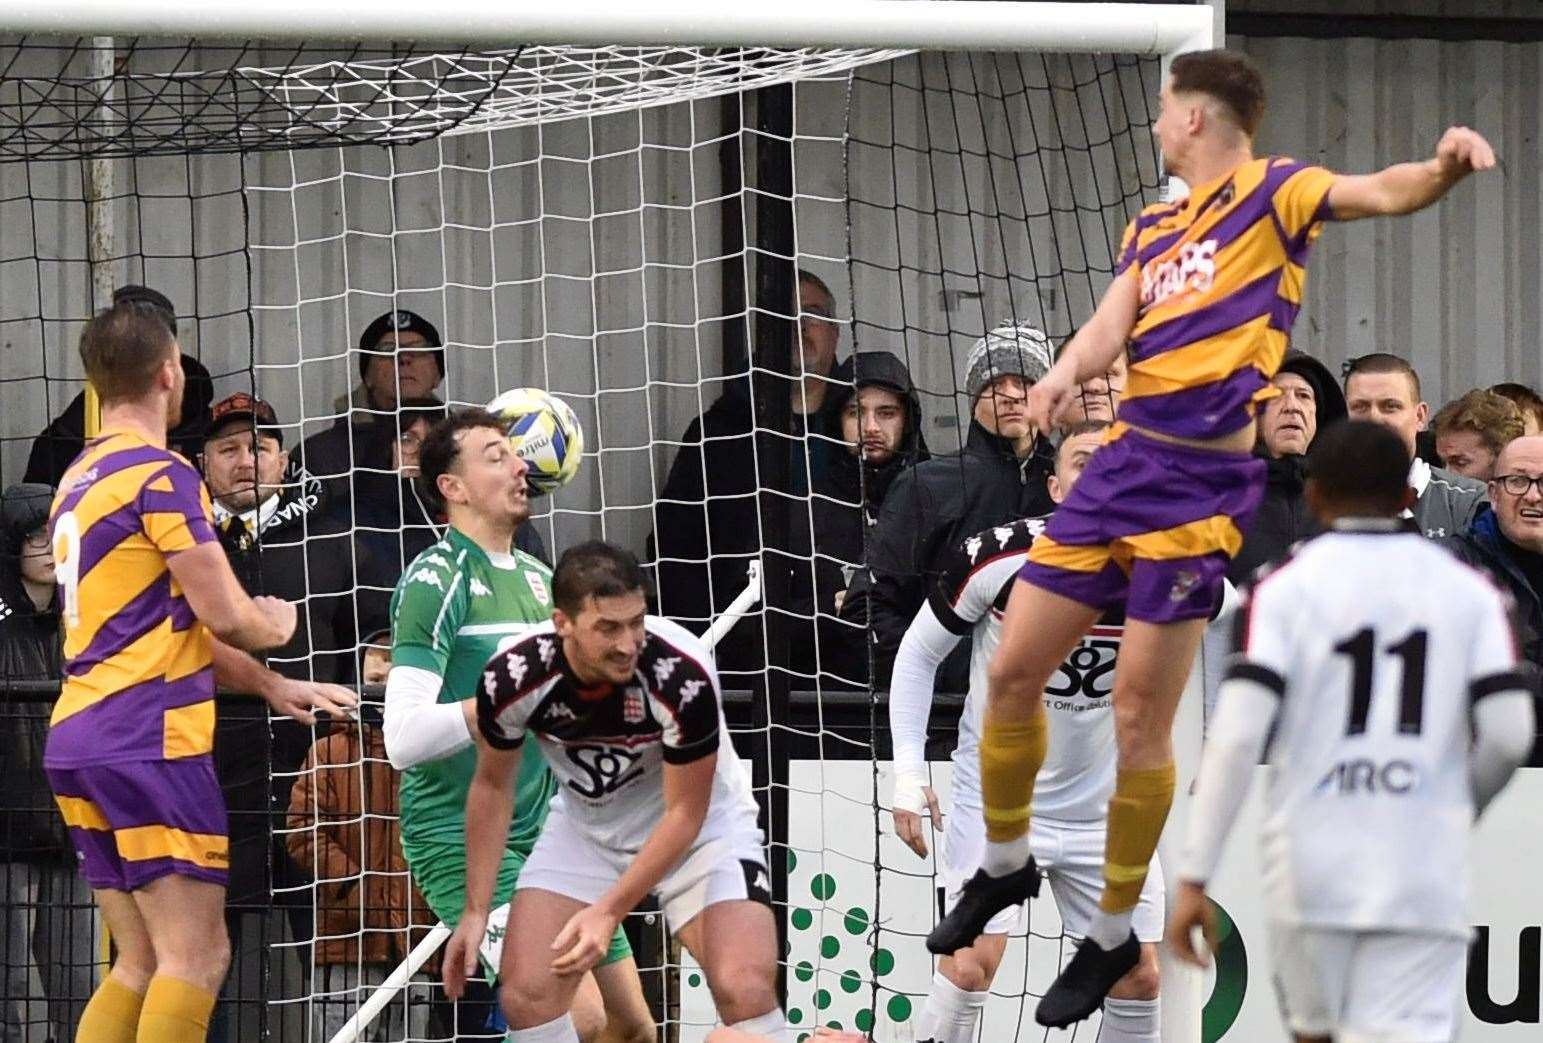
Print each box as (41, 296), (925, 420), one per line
(1227, 350), (1345, 586)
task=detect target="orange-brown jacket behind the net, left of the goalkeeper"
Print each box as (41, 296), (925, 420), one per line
(285, 724), (435, 964)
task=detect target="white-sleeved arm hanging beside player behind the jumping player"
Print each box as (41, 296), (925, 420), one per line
(889, 605), (960, 858)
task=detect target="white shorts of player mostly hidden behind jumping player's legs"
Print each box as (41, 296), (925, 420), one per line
(938, 807), (1163, 943)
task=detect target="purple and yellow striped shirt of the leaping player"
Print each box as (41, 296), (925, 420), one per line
(1116, 156), (1335, 438)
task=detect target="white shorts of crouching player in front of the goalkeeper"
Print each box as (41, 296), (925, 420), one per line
(515, 802), (772, 930)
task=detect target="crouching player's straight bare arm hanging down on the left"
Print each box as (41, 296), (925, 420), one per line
(444, 741), (520, 1000)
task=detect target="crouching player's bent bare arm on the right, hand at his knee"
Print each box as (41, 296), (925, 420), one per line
(555, 751), (717, 975)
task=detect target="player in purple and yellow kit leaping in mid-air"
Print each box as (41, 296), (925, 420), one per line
(927, 51), (1495, 1026)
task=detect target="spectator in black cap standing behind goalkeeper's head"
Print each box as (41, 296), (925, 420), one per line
(296, 309), (444, 495)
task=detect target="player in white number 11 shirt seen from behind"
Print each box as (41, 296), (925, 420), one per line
(1168, 421), (1534, 1043)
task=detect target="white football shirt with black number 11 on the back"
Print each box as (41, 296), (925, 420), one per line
(1182, 520), (1529, 935)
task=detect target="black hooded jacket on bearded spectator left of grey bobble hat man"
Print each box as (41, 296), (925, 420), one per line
(792, 352), (930, 687)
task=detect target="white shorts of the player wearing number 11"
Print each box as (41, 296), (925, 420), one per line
(1268, 923), (1467, 1043)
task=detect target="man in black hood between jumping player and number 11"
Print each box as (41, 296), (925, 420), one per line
(1227, 350), (1345, 586)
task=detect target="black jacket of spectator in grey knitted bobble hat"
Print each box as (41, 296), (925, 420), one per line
(841, 421), (1055, 691)
